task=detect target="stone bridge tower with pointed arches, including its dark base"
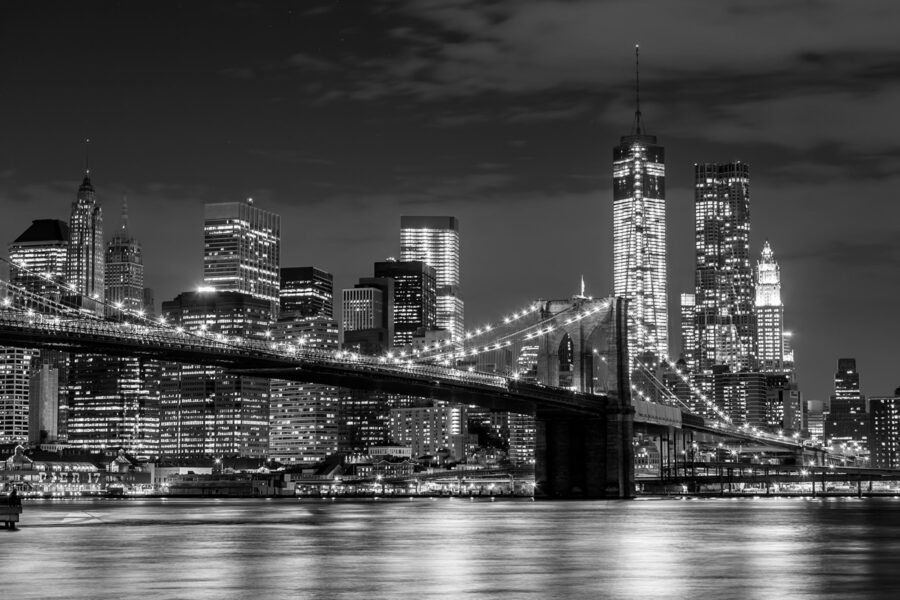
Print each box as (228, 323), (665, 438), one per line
(535, 296), (634, 498)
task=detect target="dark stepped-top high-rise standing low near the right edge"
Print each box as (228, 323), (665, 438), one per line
(825, 358), (868, 452)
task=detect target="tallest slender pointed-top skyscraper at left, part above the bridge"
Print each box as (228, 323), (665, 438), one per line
(65, 171), (105, 312)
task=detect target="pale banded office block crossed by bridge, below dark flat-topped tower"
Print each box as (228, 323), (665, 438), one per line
(269, 312), (340, 464)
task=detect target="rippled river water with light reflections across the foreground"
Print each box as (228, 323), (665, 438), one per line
(0, 498), (900, 600)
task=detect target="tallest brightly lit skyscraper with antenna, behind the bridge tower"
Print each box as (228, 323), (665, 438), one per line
(613, 49), (669, 356)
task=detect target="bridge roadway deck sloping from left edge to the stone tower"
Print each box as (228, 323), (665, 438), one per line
(0, 309), (627, 418)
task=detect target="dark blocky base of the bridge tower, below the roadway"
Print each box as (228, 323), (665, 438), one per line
(535, 414), (634, 499)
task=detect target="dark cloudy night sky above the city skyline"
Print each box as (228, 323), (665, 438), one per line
(0, 0), (900, 399)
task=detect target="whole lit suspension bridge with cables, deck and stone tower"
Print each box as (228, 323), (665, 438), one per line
(0, 267), (825, 498)
